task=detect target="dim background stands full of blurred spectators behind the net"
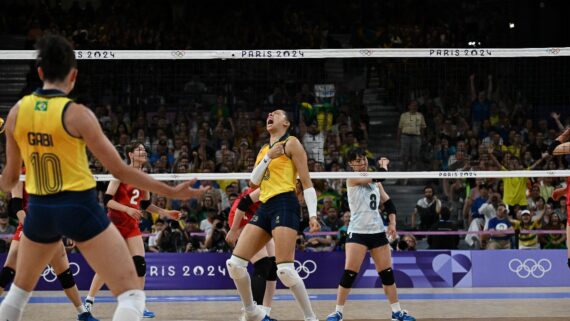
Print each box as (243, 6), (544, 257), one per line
(0, 0), (570, 252)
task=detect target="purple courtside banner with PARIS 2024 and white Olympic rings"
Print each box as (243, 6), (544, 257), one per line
(0, 250), (570, 290)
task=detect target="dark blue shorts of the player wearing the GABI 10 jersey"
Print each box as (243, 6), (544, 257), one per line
(24, 189), (111, 243)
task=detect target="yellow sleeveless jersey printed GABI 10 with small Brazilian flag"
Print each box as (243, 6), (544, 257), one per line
(14, 89), (95, 195)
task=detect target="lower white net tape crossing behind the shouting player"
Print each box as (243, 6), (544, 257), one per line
(14, 170), (570, 181)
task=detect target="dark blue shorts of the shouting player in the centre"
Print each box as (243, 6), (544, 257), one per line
(249, 192), (301, 234)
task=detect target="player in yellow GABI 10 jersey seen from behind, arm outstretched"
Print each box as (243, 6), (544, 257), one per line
(0, 35), (203, 321)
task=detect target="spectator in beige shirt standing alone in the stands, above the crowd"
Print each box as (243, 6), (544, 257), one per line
(396, 100), (426, 183)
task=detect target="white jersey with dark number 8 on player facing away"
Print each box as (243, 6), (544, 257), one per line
(347, 183), (385, 234)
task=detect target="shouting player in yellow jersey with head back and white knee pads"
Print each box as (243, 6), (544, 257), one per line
(226, 110), (320, 321)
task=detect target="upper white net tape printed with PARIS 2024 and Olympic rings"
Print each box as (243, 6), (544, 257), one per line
(0, 47), (570, 60)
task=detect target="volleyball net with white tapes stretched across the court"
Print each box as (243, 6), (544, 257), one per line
(0, 48), (570, 248)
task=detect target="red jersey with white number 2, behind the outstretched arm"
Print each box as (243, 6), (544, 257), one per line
(108, 183), (145, 239)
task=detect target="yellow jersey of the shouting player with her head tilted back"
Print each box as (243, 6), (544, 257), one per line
(255, 136), (297, 203)
